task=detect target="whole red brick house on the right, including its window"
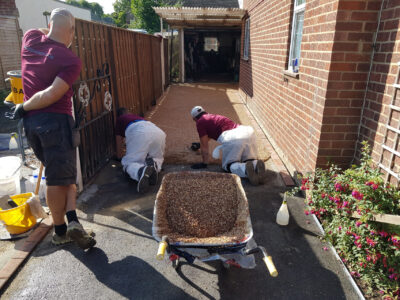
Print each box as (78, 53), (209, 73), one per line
(239, 0), (400, 180)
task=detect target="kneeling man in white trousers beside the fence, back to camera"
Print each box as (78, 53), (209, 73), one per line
(115, 107), (166, 193)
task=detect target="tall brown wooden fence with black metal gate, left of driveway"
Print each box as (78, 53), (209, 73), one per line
(71, 20), (169, 184)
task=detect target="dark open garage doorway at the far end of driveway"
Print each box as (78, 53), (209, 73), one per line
(185, 29), (241, 82)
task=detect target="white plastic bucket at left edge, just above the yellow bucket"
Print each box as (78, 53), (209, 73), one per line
(0, 156), (21, 196)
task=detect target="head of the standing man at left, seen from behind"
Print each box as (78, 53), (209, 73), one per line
(49, 8), (75, 47)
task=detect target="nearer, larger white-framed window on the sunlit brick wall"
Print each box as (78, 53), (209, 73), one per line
(288, 0), (306, 73)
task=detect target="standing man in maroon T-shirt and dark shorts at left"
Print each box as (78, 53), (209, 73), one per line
(7, 8), (96, 249)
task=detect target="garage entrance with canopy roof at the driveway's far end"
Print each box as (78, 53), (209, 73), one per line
(154, 7), (246, 82)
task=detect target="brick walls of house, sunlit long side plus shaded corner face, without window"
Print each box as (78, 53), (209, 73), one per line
(240, 0), (392, 173)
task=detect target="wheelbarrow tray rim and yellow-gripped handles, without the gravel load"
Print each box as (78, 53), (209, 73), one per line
(152, 172), (278, 277)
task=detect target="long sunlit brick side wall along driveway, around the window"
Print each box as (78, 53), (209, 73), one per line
(240, 0), (338, 172)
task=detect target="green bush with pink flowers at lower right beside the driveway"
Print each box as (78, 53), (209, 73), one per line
(295, 143), (400, 299)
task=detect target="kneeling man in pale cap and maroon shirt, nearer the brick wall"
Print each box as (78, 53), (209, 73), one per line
(191, 106), (265, 185)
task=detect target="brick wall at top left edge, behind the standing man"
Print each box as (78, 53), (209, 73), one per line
(0, 0), (22, 89)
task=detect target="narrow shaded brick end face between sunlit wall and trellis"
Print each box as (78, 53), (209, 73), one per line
(317, 0), (381, 167)
